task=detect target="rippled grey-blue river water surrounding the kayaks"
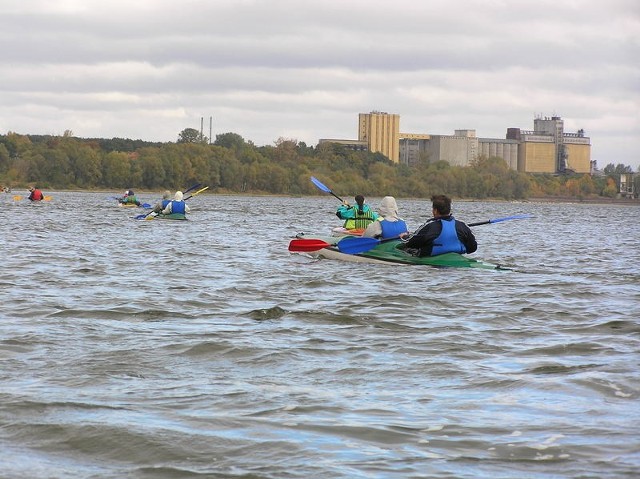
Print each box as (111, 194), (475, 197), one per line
(0, 191), (640, 479)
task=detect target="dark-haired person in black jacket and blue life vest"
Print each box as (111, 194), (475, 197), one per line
(403, 195), (478, 256)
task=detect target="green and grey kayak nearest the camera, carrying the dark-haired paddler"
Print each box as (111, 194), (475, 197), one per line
(296, 234), (508, 270)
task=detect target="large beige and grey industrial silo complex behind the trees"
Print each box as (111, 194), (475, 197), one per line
(320, 111), (591, 173)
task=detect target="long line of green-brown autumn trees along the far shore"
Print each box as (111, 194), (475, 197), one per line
(0, 128), (640, 200)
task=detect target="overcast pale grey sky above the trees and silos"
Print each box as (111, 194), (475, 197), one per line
(0, 0), (640, 170)
